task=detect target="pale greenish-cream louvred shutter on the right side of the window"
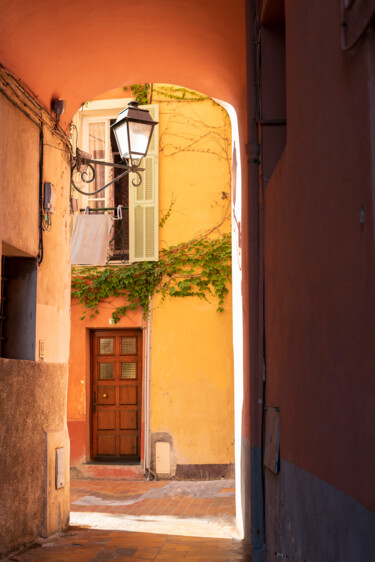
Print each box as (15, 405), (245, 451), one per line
(129, 105), (159, 262)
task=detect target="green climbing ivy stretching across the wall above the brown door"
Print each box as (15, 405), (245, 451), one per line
(72, 234), (231, 324)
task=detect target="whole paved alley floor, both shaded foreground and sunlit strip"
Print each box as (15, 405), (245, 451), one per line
(7, 480), (251, 562)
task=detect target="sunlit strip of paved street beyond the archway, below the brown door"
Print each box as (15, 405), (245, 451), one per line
(70, 480), (238, 538)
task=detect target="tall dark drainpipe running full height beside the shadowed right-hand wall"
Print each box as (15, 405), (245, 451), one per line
(246, 0), (265, 562)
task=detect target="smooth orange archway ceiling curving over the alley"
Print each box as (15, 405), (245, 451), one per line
(0, 0), (245, 122)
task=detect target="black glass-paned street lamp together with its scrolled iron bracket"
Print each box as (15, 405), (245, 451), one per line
(72, 101), (158, 196)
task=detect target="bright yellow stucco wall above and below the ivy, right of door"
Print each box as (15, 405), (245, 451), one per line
(150, 85), (234, 465)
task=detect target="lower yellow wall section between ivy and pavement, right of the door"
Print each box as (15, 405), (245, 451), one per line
(151, 290), (234, 464)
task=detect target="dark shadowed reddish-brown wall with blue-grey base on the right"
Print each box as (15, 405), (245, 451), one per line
(264, 1), (375, 560)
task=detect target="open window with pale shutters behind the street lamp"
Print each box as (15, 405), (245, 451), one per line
(79, 100), (159, 262)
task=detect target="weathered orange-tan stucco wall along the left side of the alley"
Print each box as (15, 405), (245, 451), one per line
(0, 72), (70, 555)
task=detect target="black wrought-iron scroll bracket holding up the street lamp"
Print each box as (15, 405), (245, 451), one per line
(71, 148), (145, 196)
